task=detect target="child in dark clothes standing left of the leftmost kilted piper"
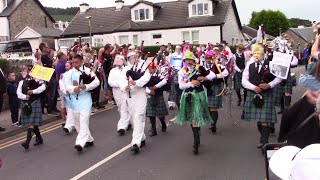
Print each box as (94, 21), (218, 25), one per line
(7, 71), (19, 127)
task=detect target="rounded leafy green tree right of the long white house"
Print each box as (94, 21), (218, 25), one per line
(249, 10), (290, 37)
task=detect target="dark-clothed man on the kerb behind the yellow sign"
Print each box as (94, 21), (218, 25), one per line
(39, 43), (60, 115)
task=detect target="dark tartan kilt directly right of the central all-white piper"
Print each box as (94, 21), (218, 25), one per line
(146, 94), (169, 117)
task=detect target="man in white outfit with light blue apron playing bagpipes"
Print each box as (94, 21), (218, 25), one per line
(63, 55), (100, 151)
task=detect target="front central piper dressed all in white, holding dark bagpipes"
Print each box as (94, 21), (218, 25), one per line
(120, 51), (153, 154)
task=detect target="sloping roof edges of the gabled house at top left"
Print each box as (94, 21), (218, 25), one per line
(0, 0), (55, 22)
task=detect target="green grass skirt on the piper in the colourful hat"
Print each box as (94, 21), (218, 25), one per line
(176, 90), (213, 126)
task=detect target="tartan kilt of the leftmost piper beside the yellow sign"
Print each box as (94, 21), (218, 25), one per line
(21, 100), (42, 126)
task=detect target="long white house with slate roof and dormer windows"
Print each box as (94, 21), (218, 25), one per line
(56, 0), (245, 47)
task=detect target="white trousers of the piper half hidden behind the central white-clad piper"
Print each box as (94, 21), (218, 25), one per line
(113, 88), (130, 130)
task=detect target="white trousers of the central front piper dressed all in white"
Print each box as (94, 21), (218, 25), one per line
(127, 88), (147, 147)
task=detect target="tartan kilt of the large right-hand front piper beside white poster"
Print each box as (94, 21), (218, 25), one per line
(244, 90), (277, 123)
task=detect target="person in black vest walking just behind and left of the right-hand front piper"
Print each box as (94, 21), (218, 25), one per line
(233, 45), (247, 106)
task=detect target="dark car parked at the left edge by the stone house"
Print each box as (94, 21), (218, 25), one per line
(0, 40), (32, 53)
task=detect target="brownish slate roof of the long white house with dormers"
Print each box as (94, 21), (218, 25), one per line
(62, 0), (238, 37)
